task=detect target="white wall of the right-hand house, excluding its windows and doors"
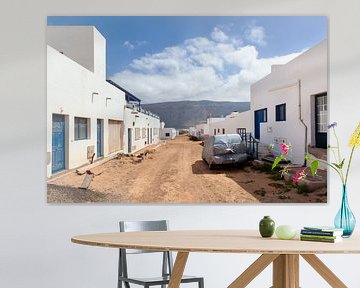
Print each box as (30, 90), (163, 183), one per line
(251, 40), (331, 164)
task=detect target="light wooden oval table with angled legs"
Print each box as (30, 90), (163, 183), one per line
(71, 230), (360, 288)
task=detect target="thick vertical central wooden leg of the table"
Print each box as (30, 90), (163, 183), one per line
(272, 254), (299, 288)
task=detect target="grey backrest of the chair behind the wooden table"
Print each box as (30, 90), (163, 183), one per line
(119, 220), (173, 277)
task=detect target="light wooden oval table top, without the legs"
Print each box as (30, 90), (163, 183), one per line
(71, 230), (360, 254)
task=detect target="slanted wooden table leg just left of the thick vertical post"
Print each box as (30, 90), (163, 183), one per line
(228, 254), (279, 288)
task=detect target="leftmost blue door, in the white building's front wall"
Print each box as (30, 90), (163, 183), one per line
(51, 114), (65, 173)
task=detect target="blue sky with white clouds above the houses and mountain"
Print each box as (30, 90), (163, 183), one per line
(48, 16), (327, 103)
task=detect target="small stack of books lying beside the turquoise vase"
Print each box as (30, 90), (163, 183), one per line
(300, 227), (344, 243)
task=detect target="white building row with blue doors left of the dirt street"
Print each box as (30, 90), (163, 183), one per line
(47, 26), (160, 177)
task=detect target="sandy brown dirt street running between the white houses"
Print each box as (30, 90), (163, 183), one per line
(48, 136), (326, 203)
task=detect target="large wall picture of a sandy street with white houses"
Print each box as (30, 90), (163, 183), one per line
(46, 16), (328, 204)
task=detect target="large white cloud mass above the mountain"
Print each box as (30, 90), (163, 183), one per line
(110, 30), (301, 103)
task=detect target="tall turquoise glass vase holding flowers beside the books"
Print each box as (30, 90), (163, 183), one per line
(334, 185), (356, 237)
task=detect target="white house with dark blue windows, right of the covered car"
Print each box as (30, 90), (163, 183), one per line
(251, 40), (328, 164)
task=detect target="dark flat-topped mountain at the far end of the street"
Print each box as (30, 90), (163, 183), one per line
(142, 100), (250, 129)
